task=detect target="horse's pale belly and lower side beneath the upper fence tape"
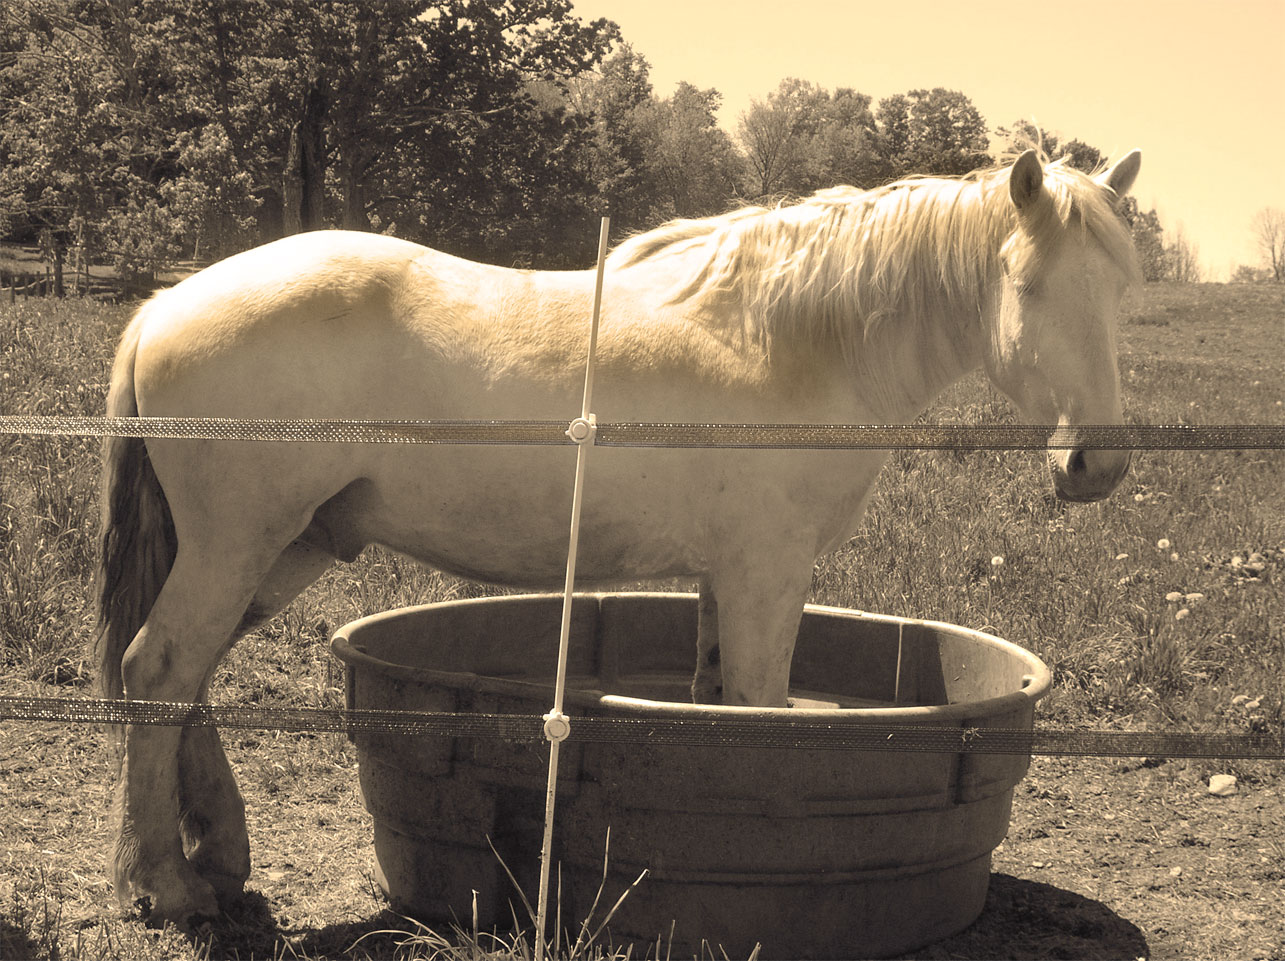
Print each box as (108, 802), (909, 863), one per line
(341, 447), (883, 587)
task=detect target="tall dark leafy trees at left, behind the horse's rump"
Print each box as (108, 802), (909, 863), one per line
(0, 0), (618, 276)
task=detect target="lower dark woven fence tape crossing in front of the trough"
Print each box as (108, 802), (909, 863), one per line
(0, 696), (1285, 761)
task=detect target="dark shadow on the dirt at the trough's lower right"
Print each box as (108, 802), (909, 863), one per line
(900, 874), (1151, 961)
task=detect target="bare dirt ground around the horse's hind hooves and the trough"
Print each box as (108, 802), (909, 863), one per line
(0, 693), (1285, 961)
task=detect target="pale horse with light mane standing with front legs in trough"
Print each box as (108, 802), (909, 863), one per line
(100, 152), (1140, 924)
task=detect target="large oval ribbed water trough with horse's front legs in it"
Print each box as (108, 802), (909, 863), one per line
(333, 594), (1050, 958)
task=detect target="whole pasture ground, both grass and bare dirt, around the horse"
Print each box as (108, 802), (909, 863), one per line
(0, 284), (1285, 960)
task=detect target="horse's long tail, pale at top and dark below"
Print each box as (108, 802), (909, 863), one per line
(98, 302), (176, 698)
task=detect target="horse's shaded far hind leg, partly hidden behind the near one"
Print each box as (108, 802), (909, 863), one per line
(179, 541), (334, 904)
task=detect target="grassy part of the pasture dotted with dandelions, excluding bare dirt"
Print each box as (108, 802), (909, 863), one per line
(0, 285), (1285, 958)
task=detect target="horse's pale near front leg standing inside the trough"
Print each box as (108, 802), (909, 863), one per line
(696, 545), (813, 708)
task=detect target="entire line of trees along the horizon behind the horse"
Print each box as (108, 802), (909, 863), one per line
(0, 0), (1195, 285)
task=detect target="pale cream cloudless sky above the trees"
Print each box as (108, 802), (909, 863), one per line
(573, 0), (1285, 280)
